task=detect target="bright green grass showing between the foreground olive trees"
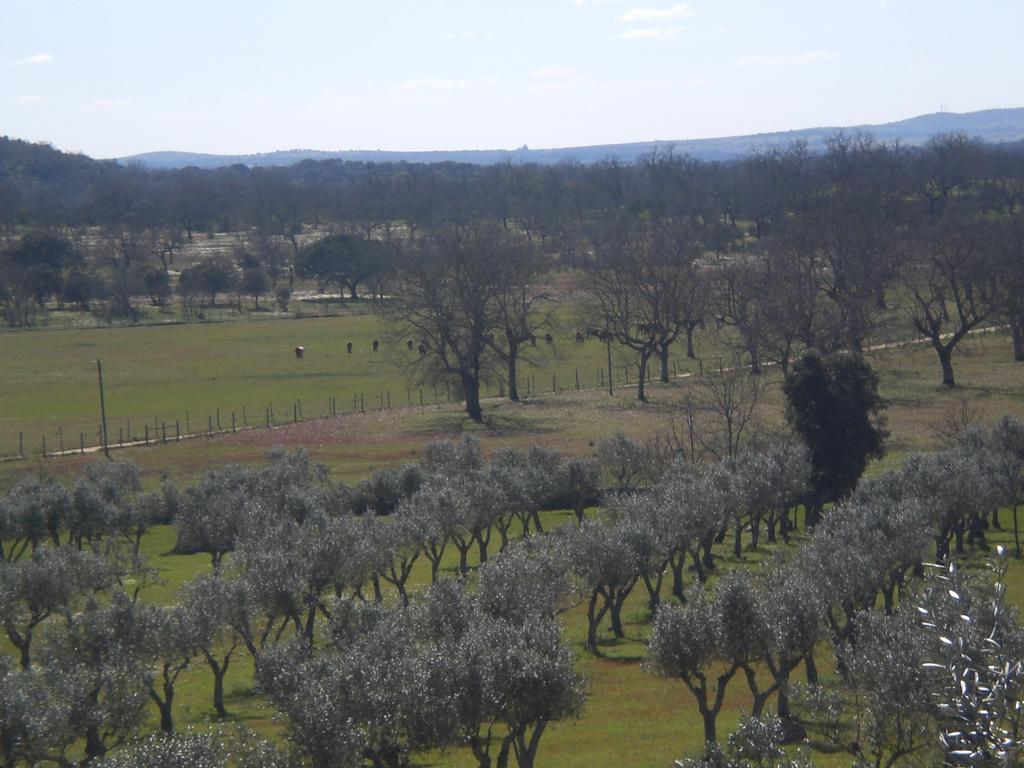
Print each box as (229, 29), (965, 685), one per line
(94, 505), (1024, 768)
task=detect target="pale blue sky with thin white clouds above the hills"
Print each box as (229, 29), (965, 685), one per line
(0, 0), (1024, 157)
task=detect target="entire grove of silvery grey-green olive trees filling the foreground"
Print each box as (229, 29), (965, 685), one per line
(6, 419), (1024, 768)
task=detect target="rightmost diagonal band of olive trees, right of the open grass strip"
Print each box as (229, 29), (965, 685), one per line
(647, 417), (1024, 766)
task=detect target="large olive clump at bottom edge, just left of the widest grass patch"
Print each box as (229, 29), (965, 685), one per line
(257, 580), (584, 768)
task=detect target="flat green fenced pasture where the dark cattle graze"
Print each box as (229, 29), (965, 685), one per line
(0, 307), (720, 457)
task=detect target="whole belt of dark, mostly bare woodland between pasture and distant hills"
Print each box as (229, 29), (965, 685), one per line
(0, 133), (1024, 403)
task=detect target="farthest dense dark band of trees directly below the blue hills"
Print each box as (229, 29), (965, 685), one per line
(0, 134), (1024, 240)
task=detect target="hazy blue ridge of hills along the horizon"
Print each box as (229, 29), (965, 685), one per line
(118, 108), (1024, 168)
